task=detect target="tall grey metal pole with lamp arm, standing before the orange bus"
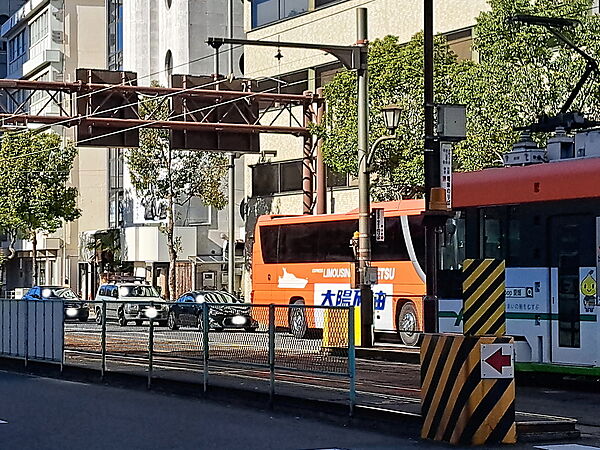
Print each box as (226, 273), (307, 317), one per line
(356, 8), (373, 347)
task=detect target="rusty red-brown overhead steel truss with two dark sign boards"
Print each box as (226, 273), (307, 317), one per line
(0, 69), (323, 153)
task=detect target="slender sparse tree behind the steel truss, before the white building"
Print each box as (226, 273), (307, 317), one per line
(126, 86), (228, 299)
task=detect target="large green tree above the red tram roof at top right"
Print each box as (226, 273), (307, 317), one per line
(456, 0), (600, 170)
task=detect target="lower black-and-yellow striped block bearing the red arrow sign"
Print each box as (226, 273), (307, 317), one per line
(421, 334), (517, 445)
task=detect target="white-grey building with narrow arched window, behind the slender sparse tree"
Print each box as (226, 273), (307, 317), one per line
(99, 0), (244, 298)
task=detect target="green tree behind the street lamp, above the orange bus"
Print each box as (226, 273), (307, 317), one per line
(316, 33), (475, 199)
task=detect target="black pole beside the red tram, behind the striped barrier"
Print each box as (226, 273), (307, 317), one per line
(423, 0), (440, 333)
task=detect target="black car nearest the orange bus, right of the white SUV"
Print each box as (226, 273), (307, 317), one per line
(168, 291), (258, 331)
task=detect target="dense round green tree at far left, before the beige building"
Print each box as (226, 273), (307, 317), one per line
(0, 132), (81, 284)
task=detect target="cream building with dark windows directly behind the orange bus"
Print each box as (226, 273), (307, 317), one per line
(239, 0), (489, 291)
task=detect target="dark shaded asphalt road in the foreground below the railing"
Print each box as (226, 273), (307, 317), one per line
(0, 372), (600, 450)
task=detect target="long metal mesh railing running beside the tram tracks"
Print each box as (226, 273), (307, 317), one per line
(23, 300), (356, 414)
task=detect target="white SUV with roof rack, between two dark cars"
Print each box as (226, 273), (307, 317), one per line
(94, 283), (169, 327)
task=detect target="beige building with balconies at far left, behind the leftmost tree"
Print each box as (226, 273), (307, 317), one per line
(0, 0), (108, 291)
